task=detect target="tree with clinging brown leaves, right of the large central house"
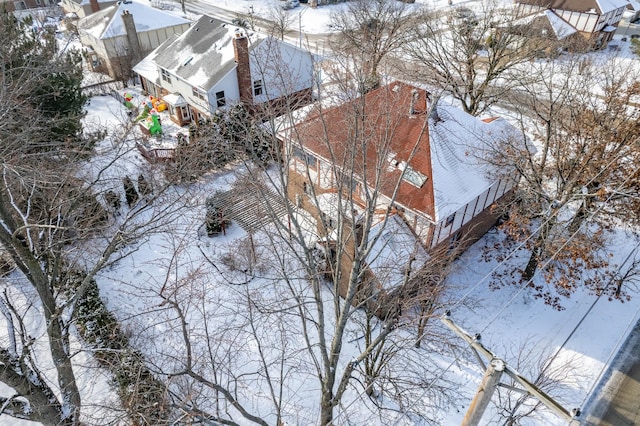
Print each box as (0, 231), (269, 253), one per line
(484, 55), (638, 294)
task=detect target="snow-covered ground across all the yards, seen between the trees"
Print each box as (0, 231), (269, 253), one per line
(0, 0), (640, 426)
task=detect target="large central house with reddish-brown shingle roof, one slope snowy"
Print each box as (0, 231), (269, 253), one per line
(280, 82), (525, 258)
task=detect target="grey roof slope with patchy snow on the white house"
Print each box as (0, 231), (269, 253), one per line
(134, 15), (260, 90)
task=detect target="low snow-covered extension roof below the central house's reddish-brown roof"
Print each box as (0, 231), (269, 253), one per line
(366, 215), (429, 290)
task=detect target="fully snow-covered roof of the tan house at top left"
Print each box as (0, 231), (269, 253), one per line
(77, 1), (191, 40)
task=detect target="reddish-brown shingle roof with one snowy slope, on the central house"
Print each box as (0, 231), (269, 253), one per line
(289, 82), (518, 221)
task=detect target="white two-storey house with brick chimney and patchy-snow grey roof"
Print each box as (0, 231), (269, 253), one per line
(133, 15), (315, 125)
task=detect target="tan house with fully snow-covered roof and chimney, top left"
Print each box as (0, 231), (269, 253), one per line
(76, 1), (191, 80)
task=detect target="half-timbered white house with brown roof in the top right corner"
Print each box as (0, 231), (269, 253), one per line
(515, 0), (632, 49)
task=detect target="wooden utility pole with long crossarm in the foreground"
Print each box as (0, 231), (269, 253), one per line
(440, 312), (580, 426)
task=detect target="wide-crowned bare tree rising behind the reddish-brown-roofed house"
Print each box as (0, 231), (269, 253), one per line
(405, 2), (560, 115)
